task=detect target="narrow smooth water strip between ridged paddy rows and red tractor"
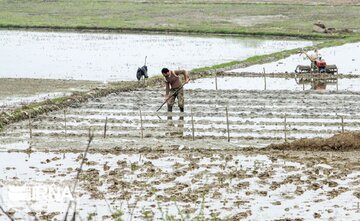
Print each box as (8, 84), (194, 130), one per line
(186, 77), (360, 91)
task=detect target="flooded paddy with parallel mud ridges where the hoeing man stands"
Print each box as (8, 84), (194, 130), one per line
(0, 90), (360, 150)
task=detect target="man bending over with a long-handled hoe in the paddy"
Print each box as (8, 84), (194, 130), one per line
(161, 68), (190, 119)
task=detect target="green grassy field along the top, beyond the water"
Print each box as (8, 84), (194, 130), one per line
(0, 0), (360, 38)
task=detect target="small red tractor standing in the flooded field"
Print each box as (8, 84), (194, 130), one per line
(295, 50), (338, 74)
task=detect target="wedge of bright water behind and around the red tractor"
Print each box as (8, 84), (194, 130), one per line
(232, 43), (360, 74)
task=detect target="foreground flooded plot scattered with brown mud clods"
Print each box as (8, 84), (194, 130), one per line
(0, 151), (360, 220)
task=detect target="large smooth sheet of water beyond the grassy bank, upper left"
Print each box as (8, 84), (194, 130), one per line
(0, 31), (312, 81)
